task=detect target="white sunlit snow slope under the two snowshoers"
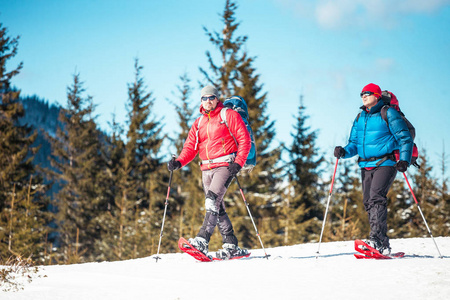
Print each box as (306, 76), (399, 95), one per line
(0, 237), (450, 300)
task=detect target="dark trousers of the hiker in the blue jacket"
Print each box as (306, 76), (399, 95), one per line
(361, 167), (397, 247)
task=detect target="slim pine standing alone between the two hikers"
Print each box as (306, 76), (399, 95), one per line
(286, 96), (325, 243)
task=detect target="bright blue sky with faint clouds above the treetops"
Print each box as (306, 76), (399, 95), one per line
(0, 0), (450, 179)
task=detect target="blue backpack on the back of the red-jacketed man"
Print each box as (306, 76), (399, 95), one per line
(220, 96), (256, 172)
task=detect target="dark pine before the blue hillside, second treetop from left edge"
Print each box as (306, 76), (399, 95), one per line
(49, 74), (106, 263)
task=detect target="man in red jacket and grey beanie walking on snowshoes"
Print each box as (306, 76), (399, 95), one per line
(167, 85), (251, 258)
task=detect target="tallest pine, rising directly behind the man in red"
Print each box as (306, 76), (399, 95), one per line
(200, 0), (281, 247)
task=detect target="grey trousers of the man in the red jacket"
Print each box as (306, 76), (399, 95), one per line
(197, 167), (238, 245)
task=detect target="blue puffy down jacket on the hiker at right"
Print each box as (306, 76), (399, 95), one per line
(343, 101), (414, 168)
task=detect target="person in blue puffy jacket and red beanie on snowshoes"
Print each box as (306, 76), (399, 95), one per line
(334, 83), (414, 255)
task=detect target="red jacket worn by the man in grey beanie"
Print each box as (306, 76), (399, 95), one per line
(177, 102), (251, 171)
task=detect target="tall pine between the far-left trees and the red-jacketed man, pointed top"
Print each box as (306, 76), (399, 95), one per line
(105, 59), (165, 259)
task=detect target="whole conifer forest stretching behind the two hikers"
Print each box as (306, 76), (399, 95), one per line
(0, 1), (450, 265)
